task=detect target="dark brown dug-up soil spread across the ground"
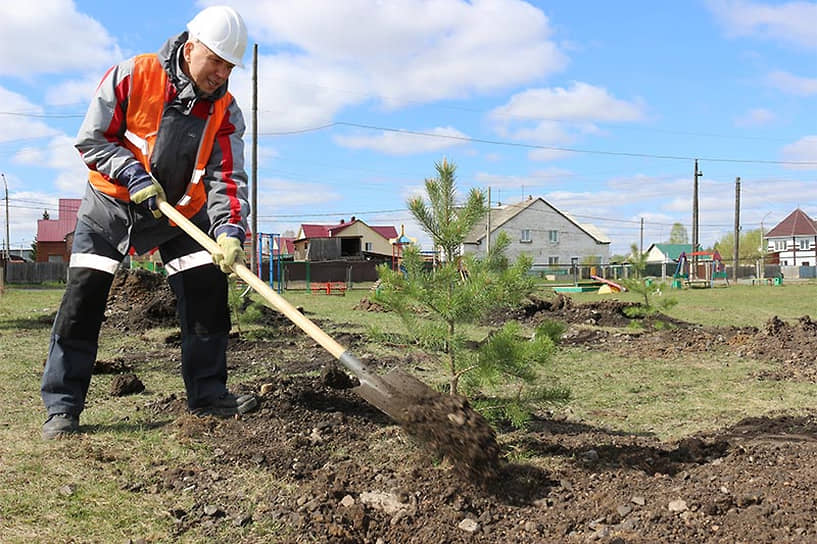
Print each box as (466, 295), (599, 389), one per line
(109, 270), (817, 544)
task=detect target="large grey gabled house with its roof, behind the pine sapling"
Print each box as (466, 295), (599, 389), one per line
(462, 197), (610, 269)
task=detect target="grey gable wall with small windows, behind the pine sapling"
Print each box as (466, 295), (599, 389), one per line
(464, 201), (610, 266)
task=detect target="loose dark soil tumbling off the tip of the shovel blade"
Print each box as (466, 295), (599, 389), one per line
(400, 395), (499, 484)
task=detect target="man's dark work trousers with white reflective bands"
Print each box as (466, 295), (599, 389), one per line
(40, 220), (230, 416)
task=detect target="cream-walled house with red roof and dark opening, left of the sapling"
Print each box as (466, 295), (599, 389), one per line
(293, 216), (397, 261)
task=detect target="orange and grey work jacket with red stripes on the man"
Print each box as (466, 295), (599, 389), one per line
(76, 32), (249, 240)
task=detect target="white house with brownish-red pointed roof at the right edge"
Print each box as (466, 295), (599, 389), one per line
(764, 208), (817, 266)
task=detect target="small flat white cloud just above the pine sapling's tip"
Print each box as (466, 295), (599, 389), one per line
(334, 127), (467, 155)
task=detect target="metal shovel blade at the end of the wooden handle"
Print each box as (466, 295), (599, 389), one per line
(353, 368), (439, 423)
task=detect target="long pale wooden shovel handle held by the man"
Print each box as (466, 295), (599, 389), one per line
(157, 199), (346, 359)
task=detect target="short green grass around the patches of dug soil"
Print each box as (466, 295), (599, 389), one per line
(0, 283), (817, 543)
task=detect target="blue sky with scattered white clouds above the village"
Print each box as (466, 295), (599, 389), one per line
(0, 0), (817, 253)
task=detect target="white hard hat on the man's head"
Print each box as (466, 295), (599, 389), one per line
(187, 6), (247, 68)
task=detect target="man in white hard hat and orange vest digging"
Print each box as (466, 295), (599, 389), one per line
(41, 6), (257, 440)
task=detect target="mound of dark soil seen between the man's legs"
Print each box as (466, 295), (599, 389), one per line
(104, 268), (178, 331)
